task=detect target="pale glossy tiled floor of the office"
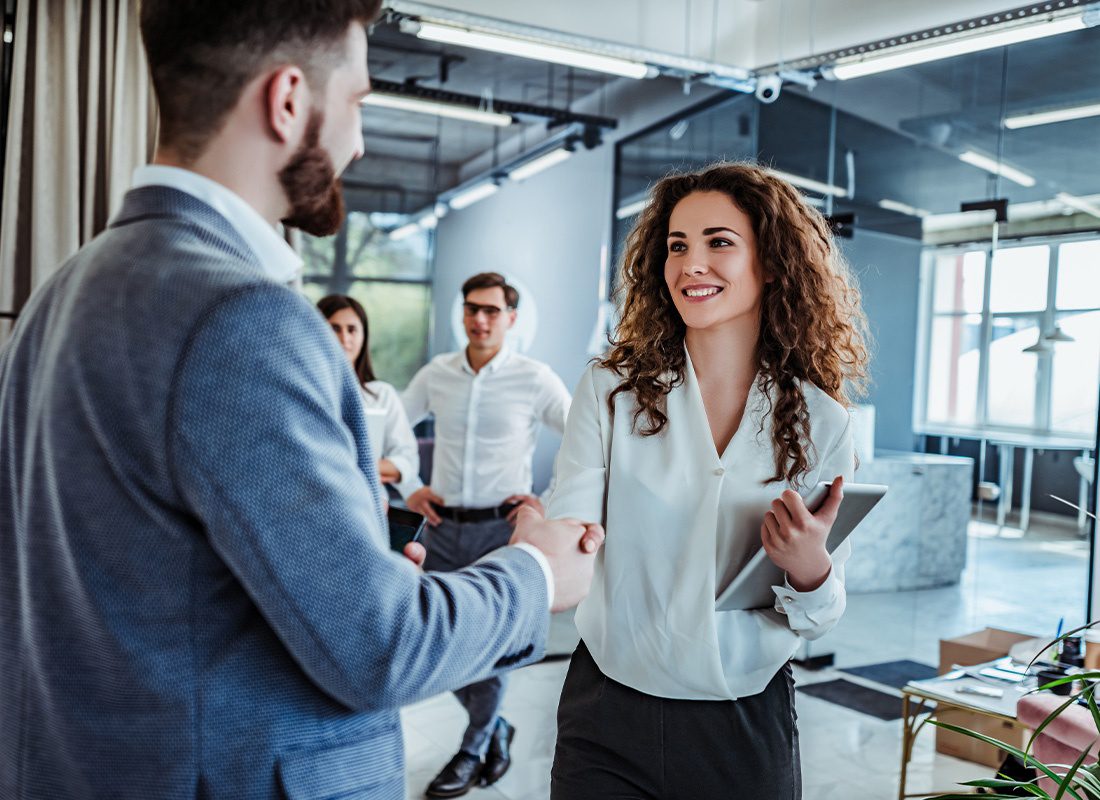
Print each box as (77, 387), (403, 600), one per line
(404, 516), (1088, 800)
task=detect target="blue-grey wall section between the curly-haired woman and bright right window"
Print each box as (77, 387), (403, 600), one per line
(840, 230), (921, 450)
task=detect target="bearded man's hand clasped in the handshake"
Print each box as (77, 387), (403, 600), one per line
(510, 505), (604, 612)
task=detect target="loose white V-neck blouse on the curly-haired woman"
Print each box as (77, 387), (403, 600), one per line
(547, 359), (855, 700)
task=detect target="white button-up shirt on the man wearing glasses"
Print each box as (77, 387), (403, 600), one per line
(402, 347), (570, 508)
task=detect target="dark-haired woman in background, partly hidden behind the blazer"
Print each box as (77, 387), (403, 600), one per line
(317, 295), (420, 497)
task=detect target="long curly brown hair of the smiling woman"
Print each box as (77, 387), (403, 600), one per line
(598, 163), (868, 483)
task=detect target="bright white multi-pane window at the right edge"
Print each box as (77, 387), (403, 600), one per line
(917, 239), (1100, 447)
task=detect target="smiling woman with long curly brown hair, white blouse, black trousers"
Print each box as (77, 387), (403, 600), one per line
(548, 164), (867, 800)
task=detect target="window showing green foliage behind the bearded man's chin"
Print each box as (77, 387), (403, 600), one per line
(301, 212), (431, 390)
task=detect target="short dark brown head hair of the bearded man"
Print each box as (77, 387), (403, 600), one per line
(141, 0), (382, 161)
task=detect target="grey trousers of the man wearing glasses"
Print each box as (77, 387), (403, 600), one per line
(422, 512), (512, 756)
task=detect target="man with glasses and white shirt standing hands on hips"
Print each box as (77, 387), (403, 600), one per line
(402, 272), (570, 798)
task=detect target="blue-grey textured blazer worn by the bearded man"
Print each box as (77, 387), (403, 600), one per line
(0, 187), (549, 800)
